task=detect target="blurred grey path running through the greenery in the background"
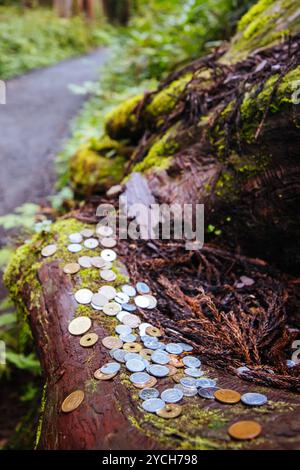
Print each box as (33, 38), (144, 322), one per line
(0, 49), (105, 215)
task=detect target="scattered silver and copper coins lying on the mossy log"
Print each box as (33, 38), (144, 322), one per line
(42, 226), (267, 439)
